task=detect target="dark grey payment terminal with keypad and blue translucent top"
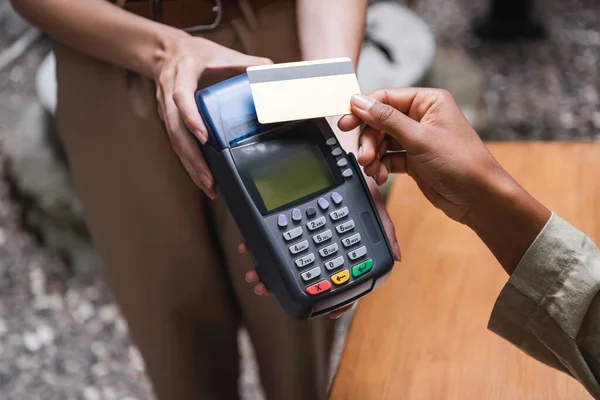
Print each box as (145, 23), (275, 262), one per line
(196, 74), (393, 319)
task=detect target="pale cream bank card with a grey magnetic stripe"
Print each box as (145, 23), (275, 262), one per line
(246, 57), (360, 124)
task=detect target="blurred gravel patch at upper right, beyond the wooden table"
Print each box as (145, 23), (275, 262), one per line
(417, 0), (600, 140)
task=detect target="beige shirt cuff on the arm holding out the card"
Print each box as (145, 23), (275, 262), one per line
(488, 213), (600, 340)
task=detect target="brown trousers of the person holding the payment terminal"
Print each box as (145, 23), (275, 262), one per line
(55, 2), (333, 400)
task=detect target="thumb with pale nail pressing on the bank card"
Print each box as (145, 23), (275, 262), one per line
(350, 94), (422, 150)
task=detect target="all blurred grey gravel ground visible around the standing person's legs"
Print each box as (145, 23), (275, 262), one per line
(0, 0), (600, 400)
